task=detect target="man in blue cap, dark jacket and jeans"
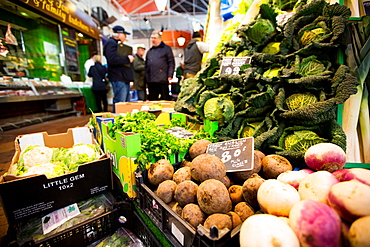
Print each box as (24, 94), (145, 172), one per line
(103, 26), (135, 112)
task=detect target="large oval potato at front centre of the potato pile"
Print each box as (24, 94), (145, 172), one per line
(197, 179), (232, 214)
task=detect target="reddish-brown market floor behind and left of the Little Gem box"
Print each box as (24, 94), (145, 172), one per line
(0, 115), (91, 246)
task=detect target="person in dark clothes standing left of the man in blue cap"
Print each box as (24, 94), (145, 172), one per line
(88, 55), (108, 112)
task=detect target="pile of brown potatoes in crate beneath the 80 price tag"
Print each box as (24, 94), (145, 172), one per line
(148, 140), (293, 233)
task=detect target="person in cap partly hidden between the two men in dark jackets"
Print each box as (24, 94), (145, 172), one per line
(132, 45), (146, 101)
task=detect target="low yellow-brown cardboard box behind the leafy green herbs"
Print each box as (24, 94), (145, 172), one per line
(115, 100), (175, 113)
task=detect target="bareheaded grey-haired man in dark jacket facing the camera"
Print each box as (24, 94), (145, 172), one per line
(145, 31), (175, 100)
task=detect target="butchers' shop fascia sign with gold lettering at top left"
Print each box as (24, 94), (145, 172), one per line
(17, 0), (100, 39)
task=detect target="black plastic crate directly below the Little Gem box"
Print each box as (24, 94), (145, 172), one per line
(8, 192), (136, 247)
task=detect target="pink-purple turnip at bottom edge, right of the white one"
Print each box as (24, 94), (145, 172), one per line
(289, 200), (341, 247)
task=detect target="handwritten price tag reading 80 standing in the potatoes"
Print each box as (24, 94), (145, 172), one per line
(207, 137), (254, 172)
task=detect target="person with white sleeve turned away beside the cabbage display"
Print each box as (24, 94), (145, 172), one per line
(184, 32), (209, 79)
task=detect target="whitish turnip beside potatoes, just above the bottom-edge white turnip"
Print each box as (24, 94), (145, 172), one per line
(257, 179), (300, 217)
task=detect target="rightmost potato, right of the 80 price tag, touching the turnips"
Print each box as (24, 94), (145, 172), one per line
(261, 154), (293, 179)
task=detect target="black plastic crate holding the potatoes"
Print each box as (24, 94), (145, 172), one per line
(136, 171), (241, 247)
